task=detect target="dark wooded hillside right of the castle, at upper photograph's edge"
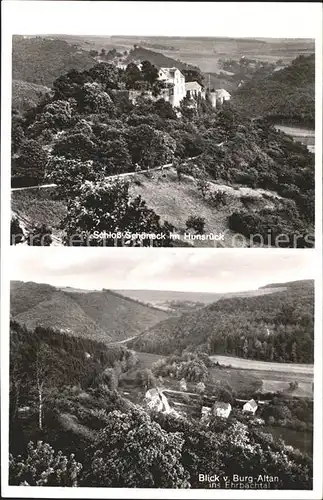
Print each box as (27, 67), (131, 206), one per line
(234, 54), (315, 127)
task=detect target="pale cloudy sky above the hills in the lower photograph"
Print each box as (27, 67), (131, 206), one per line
(10, 246), (316, 292)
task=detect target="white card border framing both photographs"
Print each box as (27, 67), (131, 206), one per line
(1, 1), (323, 500)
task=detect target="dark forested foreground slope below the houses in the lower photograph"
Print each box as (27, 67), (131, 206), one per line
(9, 323), (312, 489)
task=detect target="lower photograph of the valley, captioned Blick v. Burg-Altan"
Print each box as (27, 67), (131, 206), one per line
(8, 247), (315, 494)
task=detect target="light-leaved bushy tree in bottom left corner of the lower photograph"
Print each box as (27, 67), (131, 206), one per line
(9, 441), (82, 486)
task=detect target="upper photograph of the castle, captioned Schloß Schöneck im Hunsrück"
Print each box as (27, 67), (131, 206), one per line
(10, 34), (315, 248)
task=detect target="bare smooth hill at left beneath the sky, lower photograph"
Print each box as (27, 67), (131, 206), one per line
(10, 281), (169, 342)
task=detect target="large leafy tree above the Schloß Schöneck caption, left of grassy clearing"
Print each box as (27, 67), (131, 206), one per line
(62, 179), (173, 246)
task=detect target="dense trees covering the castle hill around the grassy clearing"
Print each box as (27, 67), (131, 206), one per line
(12, 53), (314, 247)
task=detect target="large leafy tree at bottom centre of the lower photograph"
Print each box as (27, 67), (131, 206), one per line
(83, 409), (190, 488)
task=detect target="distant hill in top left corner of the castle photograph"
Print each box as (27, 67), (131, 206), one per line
(12, 36), (95, 87)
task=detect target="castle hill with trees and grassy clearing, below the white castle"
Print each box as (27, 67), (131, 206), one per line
(12, 56), (315, 248)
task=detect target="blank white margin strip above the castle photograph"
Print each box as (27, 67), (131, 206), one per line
(2, 0), (322, 38)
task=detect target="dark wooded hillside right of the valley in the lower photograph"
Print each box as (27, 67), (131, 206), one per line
(128, 281), (314, 363)
